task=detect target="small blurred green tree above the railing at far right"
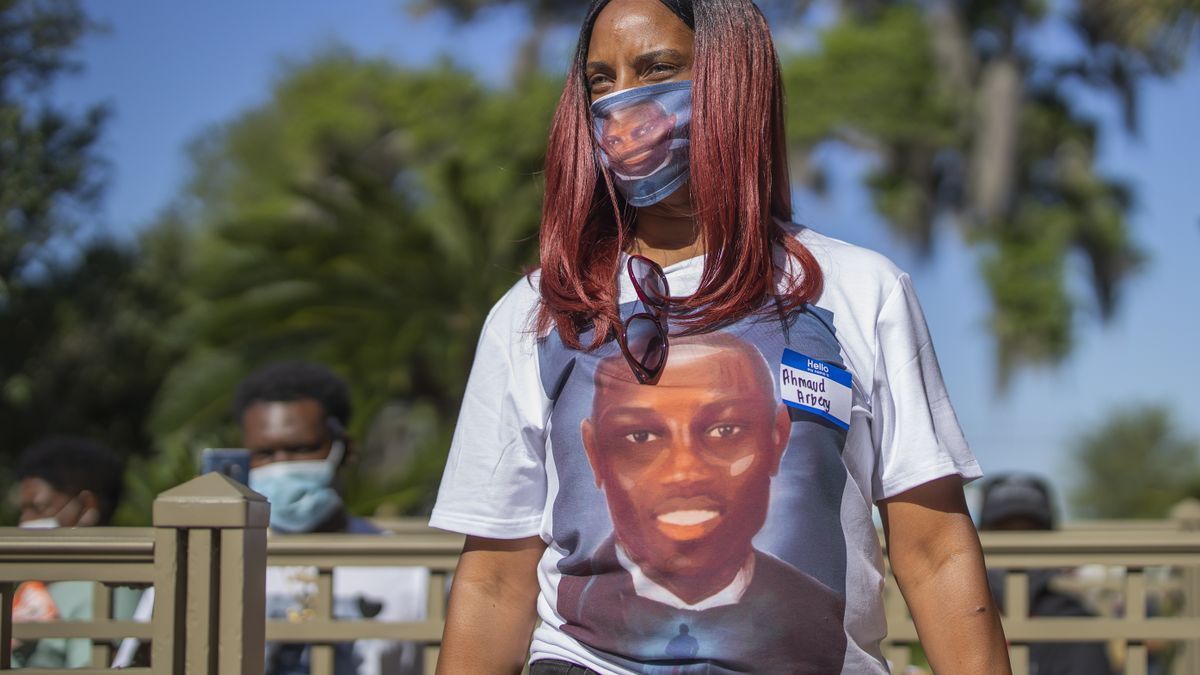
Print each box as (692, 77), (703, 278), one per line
(1072, 406), (1200, 518)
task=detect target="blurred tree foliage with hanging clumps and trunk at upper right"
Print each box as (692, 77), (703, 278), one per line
(785, 1), (1142, 386)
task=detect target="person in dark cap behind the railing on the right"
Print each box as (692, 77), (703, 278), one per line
(979, 473), (1112, 675)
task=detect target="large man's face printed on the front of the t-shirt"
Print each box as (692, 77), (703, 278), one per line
(582, 340), (791, 602)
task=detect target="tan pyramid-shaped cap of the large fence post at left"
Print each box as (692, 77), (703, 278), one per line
(154, 473), (271, 528)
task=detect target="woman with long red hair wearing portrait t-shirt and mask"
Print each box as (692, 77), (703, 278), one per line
(431, 0), (1008, 674)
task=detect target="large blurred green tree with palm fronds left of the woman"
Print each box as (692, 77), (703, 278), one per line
(155, 53), (557, 509)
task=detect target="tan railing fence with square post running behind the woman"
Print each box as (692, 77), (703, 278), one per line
(0, 474), (1200, 675)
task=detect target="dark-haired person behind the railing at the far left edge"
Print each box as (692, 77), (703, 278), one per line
(13, 436), (140, 668)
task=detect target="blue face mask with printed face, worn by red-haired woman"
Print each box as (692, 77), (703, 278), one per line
(592, 80), (691, 207)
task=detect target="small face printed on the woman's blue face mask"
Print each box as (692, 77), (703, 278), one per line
(600, 101), (676, 177)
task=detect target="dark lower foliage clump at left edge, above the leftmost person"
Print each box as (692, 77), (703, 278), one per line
(0, 223), (181, 456)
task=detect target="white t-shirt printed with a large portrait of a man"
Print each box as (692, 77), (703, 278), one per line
(430, 226), (980, 674)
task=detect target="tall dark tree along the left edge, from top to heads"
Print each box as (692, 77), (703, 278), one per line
(0, 0), (182, 516)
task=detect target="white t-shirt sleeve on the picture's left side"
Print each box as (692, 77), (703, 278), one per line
(430, 280), (550, 539)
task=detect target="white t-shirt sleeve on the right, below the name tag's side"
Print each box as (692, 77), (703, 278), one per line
(871, 274), (983, 501)
